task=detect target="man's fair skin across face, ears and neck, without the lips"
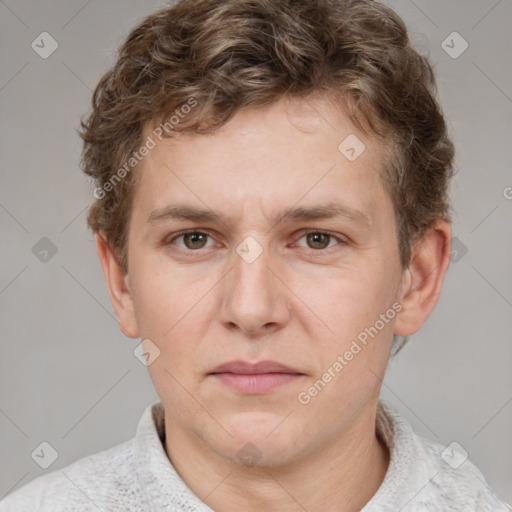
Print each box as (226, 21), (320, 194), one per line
(97, 94), (451, 512)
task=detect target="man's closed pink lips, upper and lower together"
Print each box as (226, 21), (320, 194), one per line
(209, 361), (304, 395)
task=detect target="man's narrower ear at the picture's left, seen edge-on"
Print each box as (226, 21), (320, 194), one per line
(96, 233), (139, 338)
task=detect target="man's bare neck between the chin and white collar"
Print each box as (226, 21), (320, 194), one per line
(165, 404), (390, 512)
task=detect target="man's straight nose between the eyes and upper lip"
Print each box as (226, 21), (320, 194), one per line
(219, 241), (291, 338)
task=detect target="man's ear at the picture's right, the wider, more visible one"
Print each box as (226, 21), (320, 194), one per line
(395, 220), (452, 336)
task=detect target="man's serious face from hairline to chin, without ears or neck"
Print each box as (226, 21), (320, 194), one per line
(126, 100), (403, 464)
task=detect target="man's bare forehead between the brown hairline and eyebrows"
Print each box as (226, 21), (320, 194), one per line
(134, 98), (389, 230)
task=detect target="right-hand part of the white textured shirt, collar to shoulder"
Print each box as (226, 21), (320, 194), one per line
(372, 401), (512, 512)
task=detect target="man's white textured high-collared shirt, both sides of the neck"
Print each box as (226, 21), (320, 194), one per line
(0, 401), (512, 512)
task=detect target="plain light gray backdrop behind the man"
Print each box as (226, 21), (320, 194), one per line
(0, 0), (512, 502)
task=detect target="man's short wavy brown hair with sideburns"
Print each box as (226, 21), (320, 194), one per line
(80, 0), (453, 271)
